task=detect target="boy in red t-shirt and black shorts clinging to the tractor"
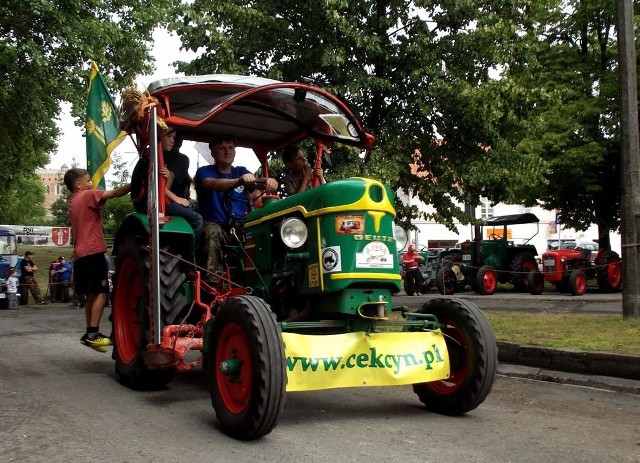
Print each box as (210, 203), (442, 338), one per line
(64, 168), (131, 352)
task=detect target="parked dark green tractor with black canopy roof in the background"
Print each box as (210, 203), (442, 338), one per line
(436, 213), (544, 295)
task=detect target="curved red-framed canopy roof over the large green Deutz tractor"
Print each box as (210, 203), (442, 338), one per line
(148, 74), (374, 153)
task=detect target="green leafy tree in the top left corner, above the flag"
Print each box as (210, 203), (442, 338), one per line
(0, 0), (171, 223)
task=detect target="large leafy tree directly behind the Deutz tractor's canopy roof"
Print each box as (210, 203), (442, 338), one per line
(170, 0), (544, 231)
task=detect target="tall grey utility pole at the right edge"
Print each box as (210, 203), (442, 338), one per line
(616, 0), (640, 318)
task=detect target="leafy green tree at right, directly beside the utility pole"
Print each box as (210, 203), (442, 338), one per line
(496, 0), (621, 247)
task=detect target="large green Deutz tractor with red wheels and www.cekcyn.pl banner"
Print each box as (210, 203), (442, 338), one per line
(113, 75), (497, 440)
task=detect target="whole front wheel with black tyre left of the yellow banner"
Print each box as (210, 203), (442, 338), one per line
(205, 296), (287, 440)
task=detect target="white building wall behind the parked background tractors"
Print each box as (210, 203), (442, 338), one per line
(397, 192), (621, 255)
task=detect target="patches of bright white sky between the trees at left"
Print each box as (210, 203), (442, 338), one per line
(46, 29), (259, 180)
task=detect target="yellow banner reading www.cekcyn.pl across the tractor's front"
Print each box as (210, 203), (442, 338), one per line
(282, 331), (449, 392)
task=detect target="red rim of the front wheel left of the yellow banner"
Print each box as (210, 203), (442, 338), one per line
(215, 323), (252, 414)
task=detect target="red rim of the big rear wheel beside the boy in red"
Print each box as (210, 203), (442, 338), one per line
(113, 257), (145, 364)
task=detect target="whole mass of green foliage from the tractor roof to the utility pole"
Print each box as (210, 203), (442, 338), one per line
(170, 0), (636, 239)
